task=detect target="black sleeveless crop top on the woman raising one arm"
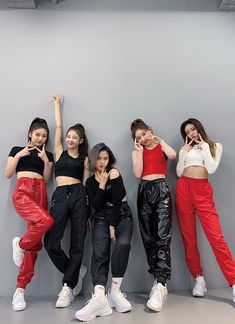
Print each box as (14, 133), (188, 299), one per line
(55, 151), (85, 181)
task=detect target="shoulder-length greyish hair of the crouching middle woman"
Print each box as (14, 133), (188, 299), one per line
(88, 143), (116, 173)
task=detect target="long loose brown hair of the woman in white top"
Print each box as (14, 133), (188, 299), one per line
(180, 118), (216, 157)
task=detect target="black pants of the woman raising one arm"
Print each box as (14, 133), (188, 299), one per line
(44, 183), (88, 289)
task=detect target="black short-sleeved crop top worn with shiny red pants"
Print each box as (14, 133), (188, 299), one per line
(8, 146), (54, 176)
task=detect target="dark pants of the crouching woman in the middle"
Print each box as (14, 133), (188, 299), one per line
(91, 202), (133, 287)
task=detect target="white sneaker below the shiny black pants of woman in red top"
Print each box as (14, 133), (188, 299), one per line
(147, 283), (168, 312)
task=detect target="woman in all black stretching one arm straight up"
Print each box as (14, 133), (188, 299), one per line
(44, 94), (89, 308)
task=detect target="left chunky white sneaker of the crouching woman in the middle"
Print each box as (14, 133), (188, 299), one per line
(75, 295), (113, 322)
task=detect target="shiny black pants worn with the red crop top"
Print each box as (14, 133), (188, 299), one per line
(137, 179), (172, 284)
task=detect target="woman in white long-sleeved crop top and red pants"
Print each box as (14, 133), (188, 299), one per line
(175, 118), (235, 302)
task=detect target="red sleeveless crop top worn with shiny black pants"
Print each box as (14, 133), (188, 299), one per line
(141, 144), (167, 177)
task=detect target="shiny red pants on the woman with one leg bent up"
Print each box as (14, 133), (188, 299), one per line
(13, 177), (53, 288)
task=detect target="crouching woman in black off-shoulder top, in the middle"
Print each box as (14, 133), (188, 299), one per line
(75, 143), (133, 321)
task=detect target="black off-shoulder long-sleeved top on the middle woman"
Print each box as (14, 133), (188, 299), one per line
(86, 171), (126, 226)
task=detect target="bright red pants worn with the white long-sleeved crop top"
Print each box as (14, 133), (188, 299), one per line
(175, 176), (235, 286)
